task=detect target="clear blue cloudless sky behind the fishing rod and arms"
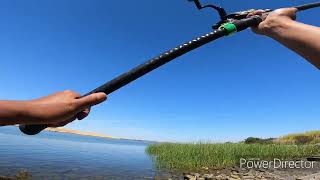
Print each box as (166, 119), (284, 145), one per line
(0, 0), (320, 141)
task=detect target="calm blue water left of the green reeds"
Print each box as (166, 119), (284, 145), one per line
(0, 127), (156, 179)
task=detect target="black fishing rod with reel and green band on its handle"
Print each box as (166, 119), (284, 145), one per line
(19, 0), (320, 135)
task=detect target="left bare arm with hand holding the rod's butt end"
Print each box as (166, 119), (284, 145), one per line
(0, 91), (106, 127)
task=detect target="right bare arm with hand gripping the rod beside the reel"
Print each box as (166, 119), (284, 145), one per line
(253, 8), (320, 69)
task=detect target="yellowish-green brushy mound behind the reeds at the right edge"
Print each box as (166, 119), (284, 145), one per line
(275, 131), (320, 145)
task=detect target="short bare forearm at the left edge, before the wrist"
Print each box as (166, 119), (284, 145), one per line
(0, 101), (32, 126)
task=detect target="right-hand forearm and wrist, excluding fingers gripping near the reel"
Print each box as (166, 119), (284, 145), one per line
(268, 20), (320, 69)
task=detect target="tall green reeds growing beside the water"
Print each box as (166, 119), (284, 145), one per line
(146, 143), (320, 170)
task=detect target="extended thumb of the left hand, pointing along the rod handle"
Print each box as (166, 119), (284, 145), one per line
(76, 93), (107, 108)
